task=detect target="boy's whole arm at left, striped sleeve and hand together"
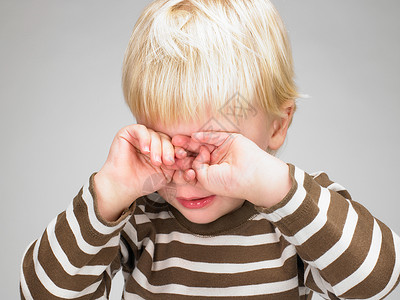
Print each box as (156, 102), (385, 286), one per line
(20, 124), (185, 299)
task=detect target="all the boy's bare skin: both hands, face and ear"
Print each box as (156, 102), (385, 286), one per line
(94, 102), (293, 224)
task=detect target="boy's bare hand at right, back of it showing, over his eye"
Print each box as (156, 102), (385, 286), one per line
(172, 131), (292, 208)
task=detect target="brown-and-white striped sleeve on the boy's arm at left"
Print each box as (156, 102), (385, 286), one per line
(20, 173), (134, 299)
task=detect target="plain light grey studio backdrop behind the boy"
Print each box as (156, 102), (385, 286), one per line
(0, 0), (400, 299)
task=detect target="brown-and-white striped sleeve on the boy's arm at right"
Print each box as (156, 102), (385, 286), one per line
(258, 164), (400, 299)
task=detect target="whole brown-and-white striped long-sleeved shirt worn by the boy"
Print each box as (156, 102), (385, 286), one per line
(20, 164), (400, 300)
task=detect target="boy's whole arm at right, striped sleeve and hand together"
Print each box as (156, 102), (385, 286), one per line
(173, 132), (400, 299)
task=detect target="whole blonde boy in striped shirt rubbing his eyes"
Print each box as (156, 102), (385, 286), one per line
(20, 0), (400, 299)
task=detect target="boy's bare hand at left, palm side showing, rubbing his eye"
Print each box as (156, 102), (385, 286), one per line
(94, 124), (186, 221)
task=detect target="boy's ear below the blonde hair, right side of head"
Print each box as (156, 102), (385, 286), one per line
(268, 100), (296, 151)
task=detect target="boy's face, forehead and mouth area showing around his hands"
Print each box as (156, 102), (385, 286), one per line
(137, 110), (271, 224)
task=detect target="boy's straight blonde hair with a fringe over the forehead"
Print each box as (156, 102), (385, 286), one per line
(122, 0), (300, 125)
